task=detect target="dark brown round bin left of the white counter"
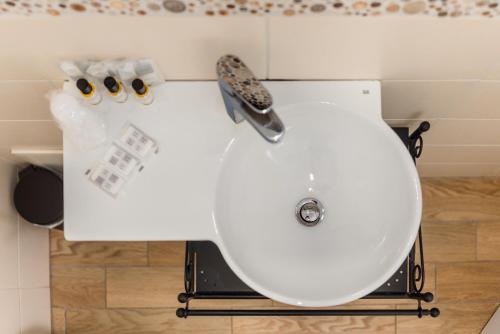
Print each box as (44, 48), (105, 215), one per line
(14, 166), (64, 225)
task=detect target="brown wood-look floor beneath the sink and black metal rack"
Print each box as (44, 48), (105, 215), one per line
(51, 178), (500, 334)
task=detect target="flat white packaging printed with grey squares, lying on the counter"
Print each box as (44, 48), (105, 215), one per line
(86, 124), (158, 197)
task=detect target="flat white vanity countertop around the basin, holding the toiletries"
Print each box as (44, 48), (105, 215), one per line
(64, 81), (381, 241)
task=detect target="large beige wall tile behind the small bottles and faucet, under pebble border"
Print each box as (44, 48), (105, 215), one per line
(0, 16), (266, 80)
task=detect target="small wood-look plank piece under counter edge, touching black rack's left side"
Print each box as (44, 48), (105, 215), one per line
(148, 241), (186, 266)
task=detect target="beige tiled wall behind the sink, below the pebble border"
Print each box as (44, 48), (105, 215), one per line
(0, 15), (500, 176)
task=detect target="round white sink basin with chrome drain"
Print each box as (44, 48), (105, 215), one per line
(214, 103), (422, 306)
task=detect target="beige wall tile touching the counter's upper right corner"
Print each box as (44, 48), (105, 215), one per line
(382, 80), (500, 119)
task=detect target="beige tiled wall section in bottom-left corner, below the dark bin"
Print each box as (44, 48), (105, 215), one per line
(0, 160), (50, 334)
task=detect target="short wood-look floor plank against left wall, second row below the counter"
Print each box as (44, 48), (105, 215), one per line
(51, 266), (106, 308)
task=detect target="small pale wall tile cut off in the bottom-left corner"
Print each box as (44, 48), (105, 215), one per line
(0, 289), (21, 334)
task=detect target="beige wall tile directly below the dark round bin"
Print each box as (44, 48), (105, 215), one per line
(19, 218), (50, 288)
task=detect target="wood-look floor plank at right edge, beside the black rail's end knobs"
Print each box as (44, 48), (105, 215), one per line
(436, 262), (500, 302)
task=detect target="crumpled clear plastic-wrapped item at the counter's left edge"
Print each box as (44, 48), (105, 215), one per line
(49, 91), (107, 151)
